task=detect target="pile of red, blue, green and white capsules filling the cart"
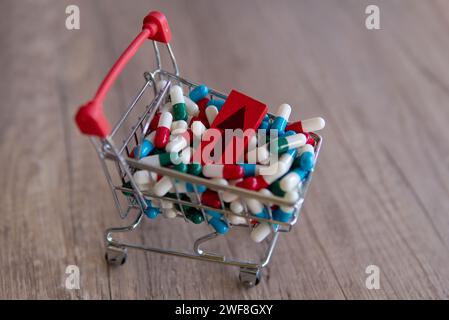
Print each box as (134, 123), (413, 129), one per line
(125, 81), (325, 242)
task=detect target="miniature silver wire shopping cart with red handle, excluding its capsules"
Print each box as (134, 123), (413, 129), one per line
(76, 12), (322, 287)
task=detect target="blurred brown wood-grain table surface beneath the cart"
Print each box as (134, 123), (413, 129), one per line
(0, 0), (449, 299)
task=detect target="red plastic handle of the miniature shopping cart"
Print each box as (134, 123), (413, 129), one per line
(75, 11), (171, 138)
